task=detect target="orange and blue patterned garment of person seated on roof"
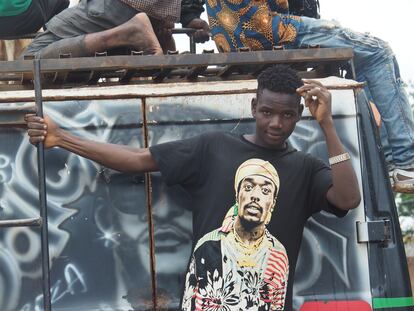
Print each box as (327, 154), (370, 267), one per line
(207, 0), (300, 52)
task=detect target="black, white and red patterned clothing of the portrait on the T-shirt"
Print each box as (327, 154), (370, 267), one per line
(182, 218), (289, 311)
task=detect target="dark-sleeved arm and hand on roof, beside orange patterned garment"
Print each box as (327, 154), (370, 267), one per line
(180, 0), (211, 43)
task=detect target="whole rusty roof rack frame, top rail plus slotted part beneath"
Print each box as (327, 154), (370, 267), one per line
(0, 48), (354, 90)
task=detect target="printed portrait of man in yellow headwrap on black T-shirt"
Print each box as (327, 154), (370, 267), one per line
(182, 159), (289, 310)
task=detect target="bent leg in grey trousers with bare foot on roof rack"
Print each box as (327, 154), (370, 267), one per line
(24, 0), (160, 58)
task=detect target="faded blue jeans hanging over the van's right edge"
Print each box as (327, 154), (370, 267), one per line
(291, 17), (414, 169)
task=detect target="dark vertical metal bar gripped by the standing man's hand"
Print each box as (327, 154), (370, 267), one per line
(33, 59), (52, 311)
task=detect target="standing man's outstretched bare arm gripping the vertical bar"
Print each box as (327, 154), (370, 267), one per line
(25, 115), (159, 173)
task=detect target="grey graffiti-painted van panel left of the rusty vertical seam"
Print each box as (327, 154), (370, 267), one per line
(0, 100), (151, 311)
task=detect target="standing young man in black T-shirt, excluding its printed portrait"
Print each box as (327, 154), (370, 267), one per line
(26, 65), (360, 310)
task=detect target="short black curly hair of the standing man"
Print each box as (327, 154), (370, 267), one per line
(257, 65), (303, 94)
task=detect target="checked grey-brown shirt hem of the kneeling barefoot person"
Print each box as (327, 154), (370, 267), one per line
(117, 0), (181, 22)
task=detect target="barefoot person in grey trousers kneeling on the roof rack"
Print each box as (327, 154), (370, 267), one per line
(19, 0), (210, 58)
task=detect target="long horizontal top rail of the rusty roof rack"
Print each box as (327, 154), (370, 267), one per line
(0, 48), (353, 73)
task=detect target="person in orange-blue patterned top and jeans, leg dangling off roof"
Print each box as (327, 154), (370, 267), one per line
(204, 0), (414, 193)
